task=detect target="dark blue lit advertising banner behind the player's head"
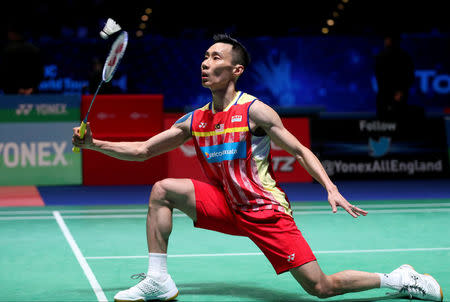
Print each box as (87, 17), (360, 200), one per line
(33, 35), (450, 112)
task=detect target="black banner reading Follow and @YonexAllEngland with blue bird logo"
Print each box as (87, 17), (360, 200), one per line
(311, 118), (449, 179)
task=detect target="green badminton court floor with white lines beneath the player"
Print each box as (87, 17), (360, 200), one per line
(0, 198), (450, 301)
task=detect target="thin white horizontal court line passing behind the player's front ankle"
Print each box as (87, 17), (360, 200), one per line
(85, 247), (450, 260)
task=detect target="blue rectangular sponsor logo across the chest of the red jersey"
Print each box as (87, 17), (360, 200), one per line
(200, 141), (247, 163)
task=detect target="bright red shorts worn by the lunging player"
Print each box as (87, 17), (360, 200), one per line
(192, 180), (316, 274)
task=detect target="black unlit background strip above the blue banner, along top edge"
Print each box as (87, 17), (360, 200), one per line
(0, 0), (450, 39)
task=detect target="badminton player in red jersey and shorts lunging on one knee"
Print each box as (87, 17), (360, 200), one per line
(73, 35), (442, 301)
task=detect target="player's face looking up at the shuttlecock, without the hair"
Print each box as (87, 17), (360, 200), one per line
(201, 43), (236, 90)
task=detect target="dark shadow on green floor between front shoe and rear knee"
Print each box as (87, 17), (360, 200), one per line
(177, 282), (317, 302)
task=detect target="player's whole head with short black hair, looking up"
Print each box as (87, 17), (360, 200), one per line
(201, 34), (250, 90)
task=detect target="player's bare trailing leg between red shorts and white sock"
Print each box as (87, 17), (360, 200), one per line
(290, 261), (380, 298)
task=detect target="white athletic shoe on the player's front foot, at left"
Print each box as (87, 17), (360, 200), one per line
(114, 274), (178, 302)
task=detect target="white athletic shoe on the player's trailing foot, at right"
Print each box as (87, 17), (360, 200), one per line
(391, 264), (444, 301)
